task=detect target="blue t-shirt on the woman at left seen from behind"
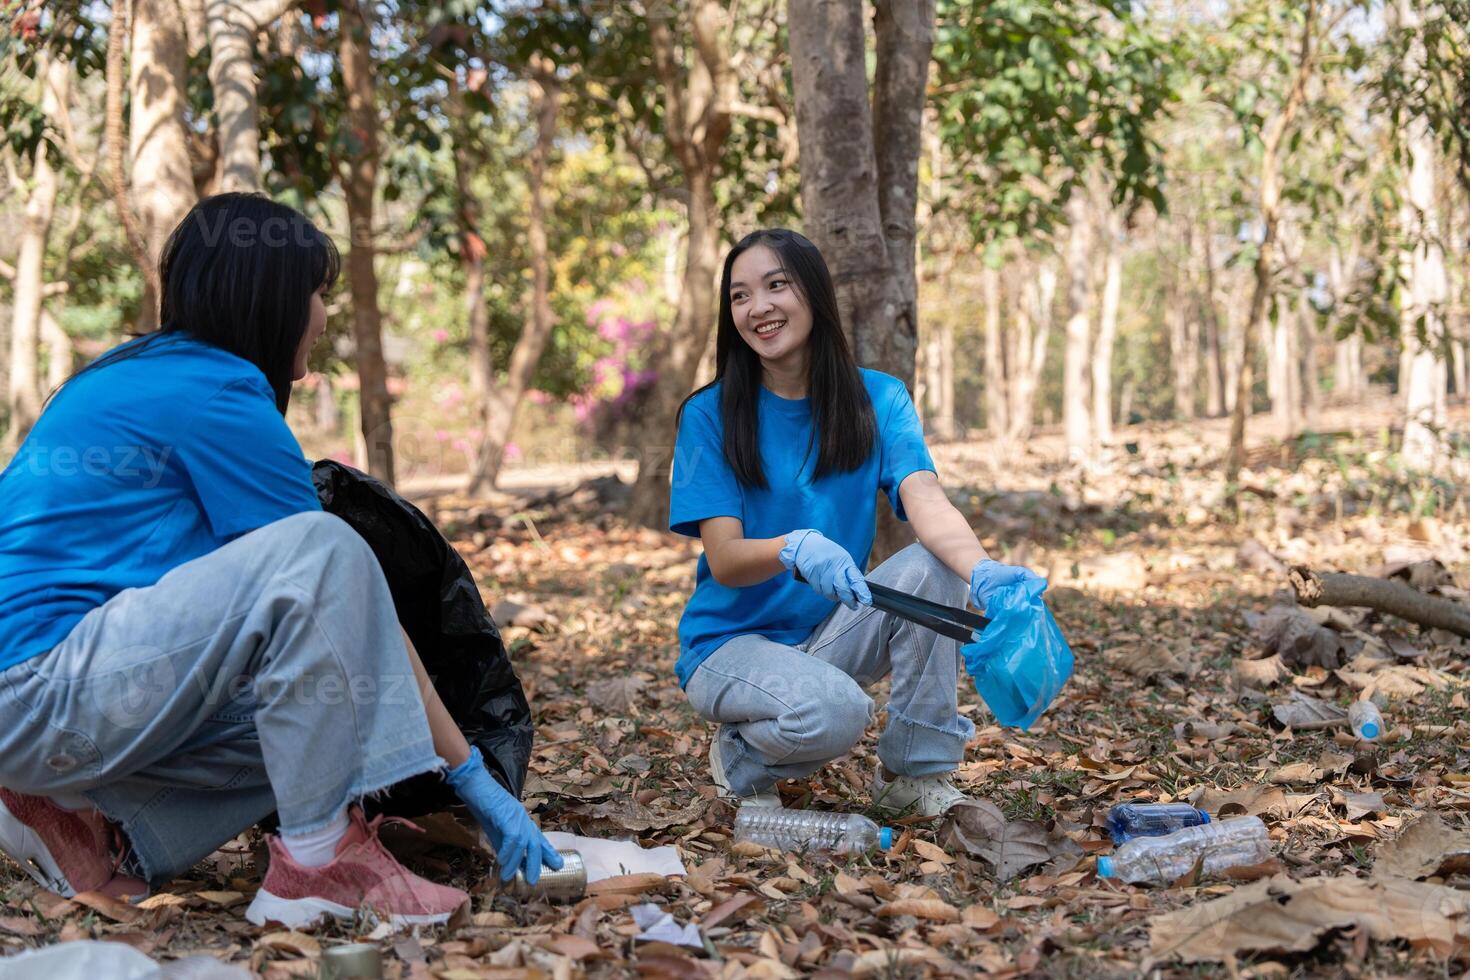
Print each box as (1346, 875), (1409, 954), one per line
(0, 332), (322, 669)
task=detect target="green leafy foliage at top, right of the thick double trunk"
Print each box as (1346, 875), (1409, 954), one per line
(933, 0), (1179, 242)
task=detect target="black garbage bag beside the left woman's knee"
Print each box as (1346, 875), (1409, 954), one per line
(312, 460), (532, 817)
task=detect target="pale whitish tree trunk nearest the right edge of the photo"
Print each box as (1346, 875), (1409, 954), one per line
(1397, 0), (1449, 472)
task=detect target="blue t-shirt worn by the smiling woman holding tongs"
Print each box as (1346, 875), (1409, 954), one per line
(669, 369), (933, 686)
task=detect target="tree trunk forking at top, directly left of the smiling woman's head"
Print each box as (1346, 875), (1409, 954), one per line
(628, 0), (736, 530)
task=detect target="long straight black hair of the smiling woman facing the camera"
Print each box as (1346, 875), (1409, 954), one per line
(679, 228), (878, 489)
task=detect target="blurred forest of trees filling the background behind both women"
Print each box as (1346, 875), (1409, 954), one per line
(0, 0), (1470, 526)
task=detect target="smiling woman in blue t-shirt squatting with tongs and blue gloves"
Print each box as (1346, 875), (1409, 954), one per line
(669, 231), (1035, 815)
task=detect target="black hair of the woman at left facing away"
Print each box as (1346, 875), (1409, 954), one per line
(51, 194), (341, 414)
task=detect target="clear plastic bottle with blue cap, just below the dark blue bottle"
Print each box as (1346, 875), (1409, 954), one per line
(1098, 817), (1272, 883)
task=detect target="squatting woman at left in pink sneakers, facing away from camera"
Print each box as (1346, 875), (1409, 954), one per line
(0, 194), (560, 926)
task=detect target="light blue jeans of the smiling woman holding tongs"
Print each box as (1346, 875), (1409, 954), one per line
(685, 544), (975, 796)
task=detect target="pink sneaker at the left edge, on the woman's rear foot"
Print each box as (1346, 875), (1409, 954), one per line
(0, 789), (148, 898)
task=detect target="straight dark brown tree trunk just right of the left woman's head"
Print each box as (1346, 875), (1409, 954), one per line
(338, 0), (394, 486)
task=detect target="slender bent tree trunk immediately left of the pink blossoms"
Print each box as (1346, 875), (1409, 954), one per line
(466, 54), (560, 495)
